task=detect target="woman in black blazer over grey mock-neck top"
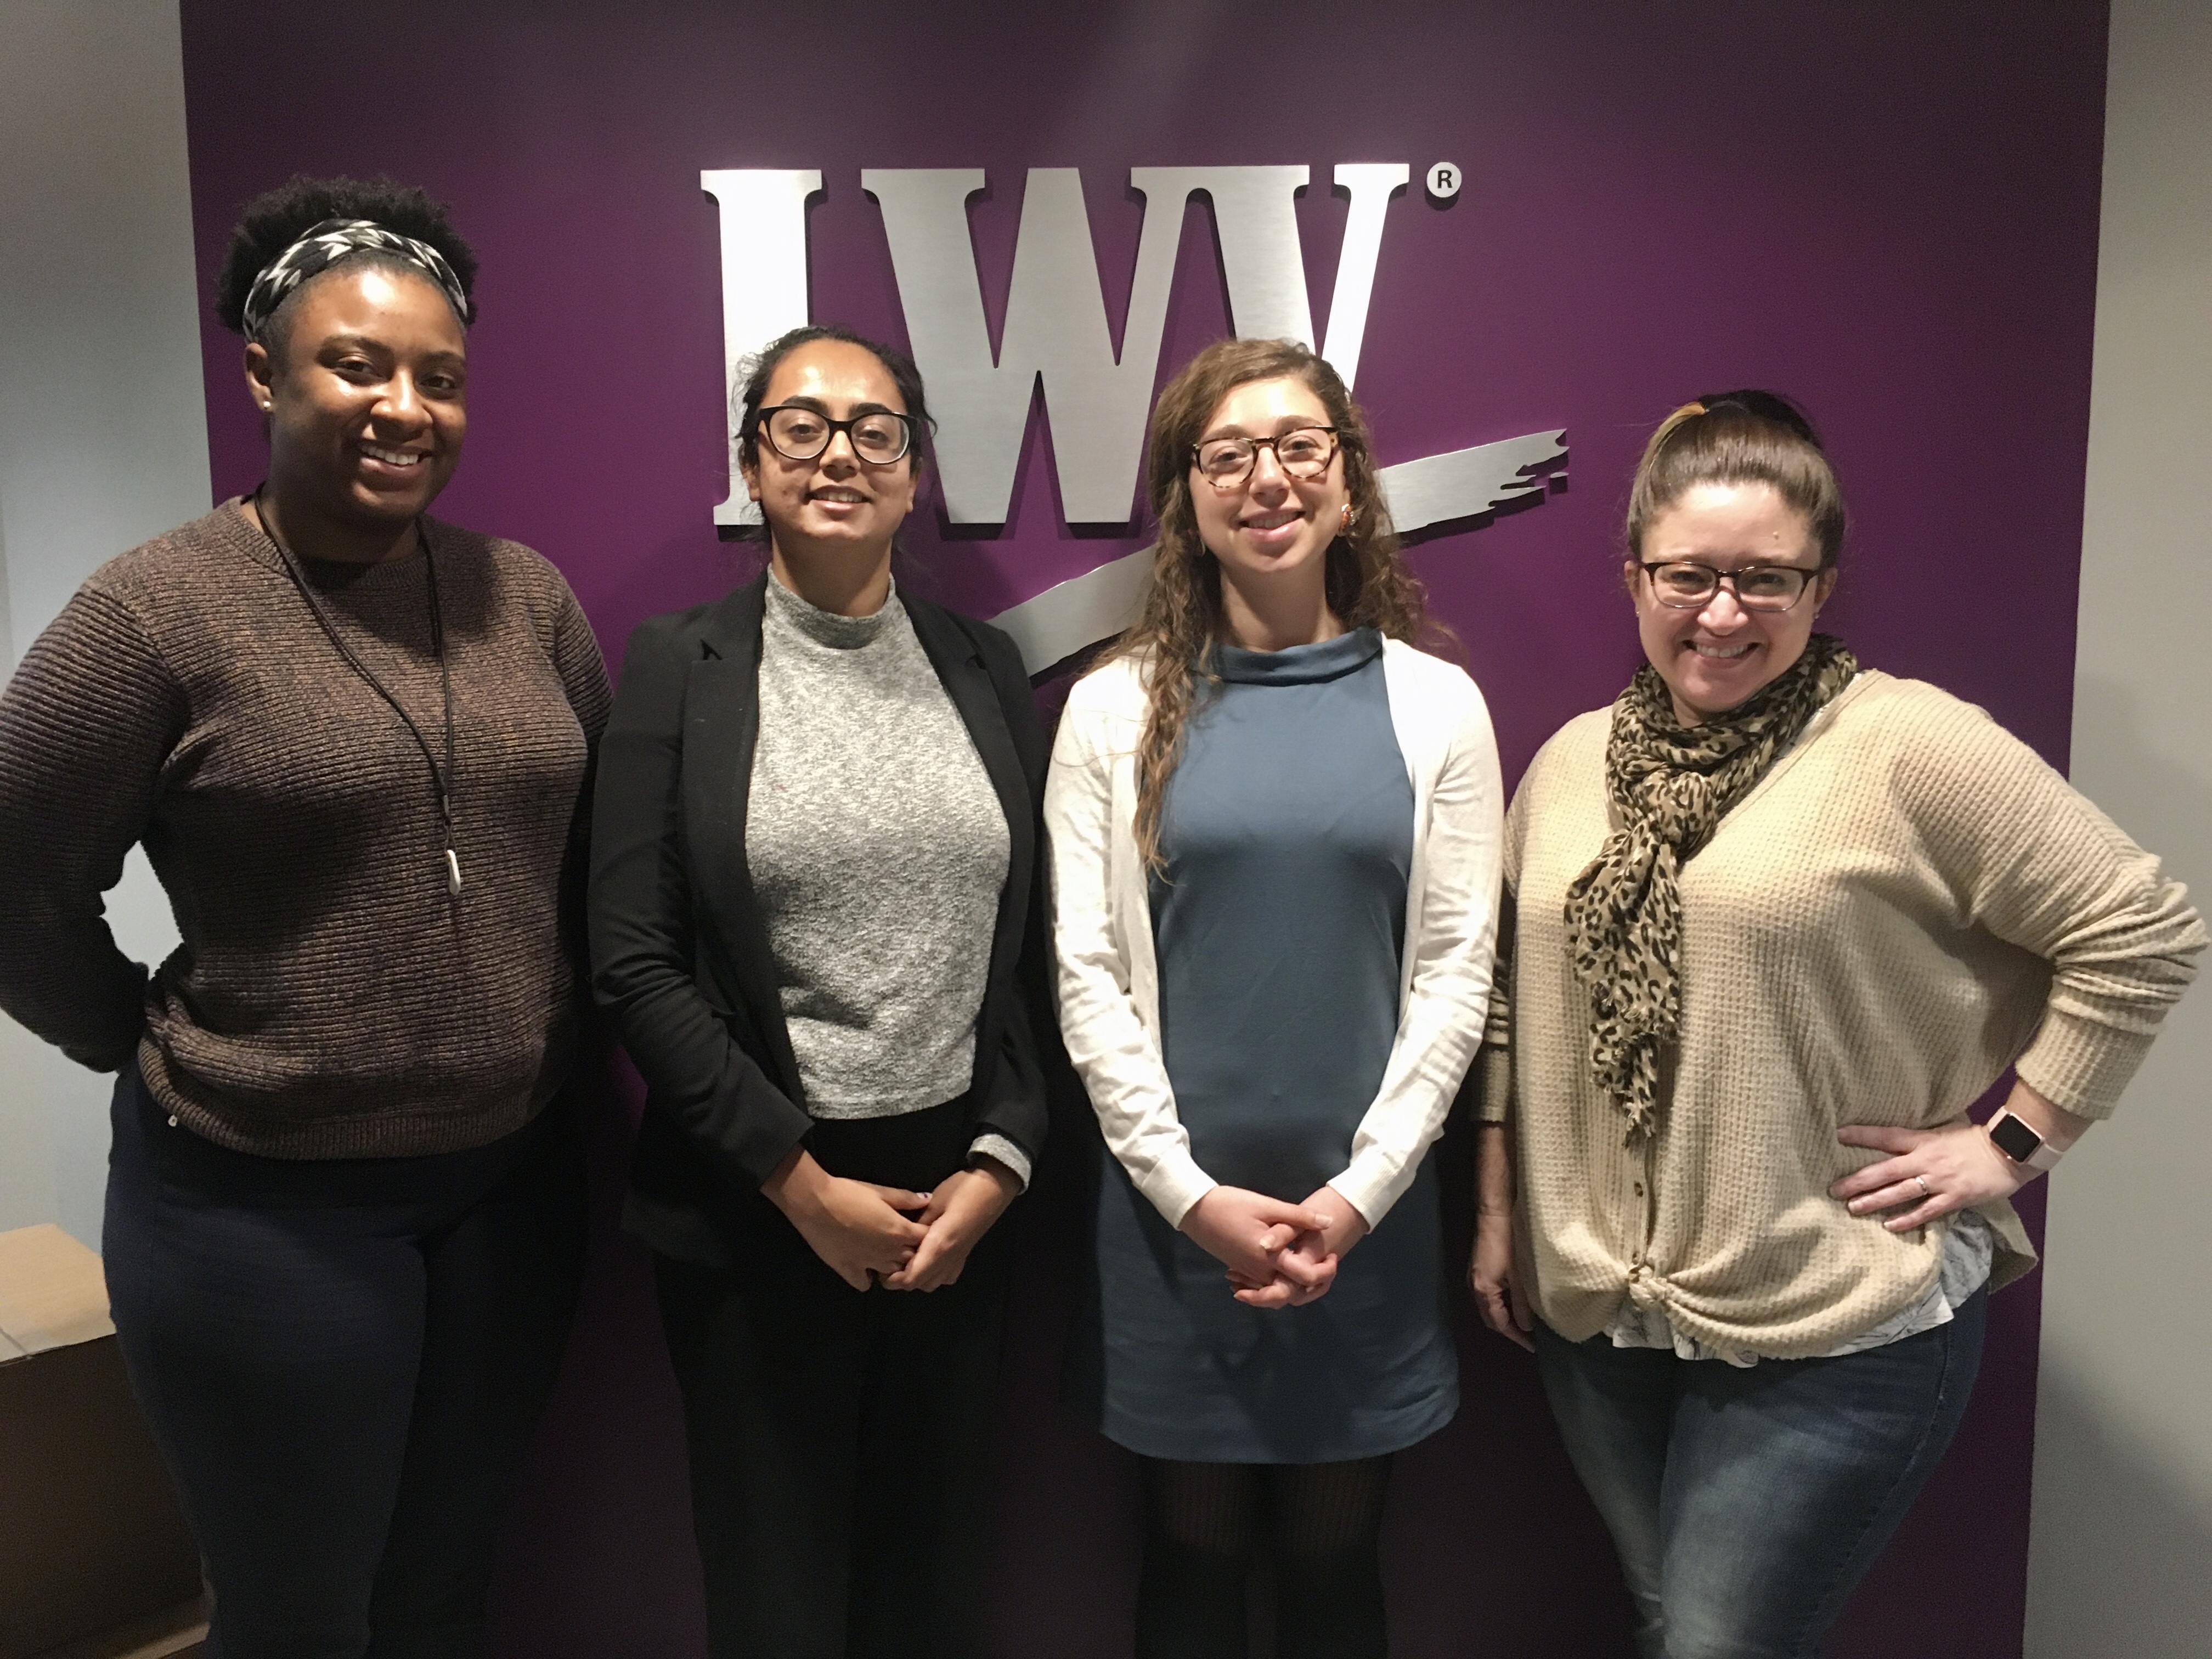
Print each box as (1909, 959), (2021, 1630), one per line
(591, 328), (1046, 1659)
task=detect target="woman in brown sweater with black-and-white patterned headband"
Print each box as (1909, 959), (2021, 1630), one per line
(0, 179), (608, 1659)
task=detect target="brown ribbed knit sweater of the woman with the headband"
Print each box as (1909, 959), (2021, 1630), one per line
(0, 502), (608, 1159)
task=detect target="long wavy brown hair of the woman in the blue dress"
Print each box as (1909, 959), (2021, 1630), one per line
(1108, 341), (1431, 872)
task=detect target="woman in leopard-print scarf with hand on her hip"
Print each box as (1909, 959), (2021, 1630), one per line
(1473, 392), (2205, 1659)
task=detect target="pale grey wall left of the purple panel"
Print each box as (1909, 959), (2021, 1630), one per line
(0, 0), (208, 1248)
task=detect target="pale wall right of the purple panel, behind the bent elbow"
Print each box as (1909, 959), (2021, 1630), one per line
(2026, 0), (2212, 1659)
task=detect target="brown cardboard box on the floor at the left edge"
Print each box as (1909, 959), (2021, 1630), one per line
(0, 1226), (199, 1659)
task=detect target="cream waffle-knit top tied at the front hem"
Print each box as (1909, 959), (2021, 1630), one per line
(1482, 673), (2205, 1358)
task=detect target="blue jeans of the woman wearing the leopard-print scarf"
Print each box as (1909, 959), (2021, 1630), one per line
(1535, 1290), (1989, 1659)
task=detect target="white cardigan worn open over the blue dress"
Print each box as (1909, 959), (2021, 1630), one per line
(1044, 639), (1504, 1228)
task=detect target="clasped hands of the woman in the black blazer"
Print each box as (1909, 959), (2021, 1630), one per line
(761, 1148), (1022, 1290)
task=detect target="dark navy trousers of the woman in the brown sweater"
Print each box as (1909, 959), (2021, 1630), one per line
(101, 1070), (584, 1659)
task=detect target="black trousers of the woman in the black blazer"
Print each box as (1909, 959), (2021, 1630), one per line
(654, 1102), (1011, 1659)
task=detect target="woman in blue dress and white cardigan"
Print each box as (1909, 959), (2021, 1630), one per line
(1044, 341), (1502, 1659)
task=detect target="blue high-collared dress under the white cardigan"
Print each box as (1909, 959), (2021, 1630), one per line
(1077, 628), (1458, 1462)
